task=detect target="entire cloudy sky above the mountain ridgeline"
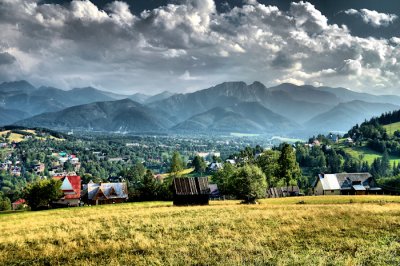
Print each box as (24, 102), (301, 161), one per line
(0, 0), (400, 94)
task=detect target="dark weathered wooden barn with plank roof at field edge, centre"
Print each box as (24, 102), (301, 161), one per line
(172, 177), (210, 206)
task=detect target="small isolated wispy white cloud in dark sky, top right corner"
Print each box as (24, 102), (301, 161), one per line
(344, 8), (398, 28)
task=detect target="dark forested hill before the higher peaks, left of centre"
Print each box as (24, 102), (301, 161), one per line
(16, 99), (171, 132)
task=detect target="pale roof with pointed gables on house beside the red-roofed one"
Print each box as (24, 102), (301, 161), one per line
(87, 182), (128, 200)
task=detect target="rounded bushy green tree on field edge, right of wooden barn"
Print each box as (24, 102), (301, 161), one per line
(232, 164), (267, 203)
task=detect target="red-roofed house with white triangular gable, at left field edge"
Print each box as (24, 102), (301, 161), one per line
(53, 176), (81, 206)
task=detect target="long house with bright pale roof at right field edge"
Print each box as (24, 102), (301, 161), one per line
(313, 173), (382, 195)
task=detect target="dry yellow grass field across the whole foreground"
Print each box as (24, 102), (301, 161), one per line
(0, 196), (400, 265)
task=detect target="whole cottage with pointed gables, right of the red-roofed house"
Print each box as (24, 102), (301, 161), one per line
(83, 181), (128, 205)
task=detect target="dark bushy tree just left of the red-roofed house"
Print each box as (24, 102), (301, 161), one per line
(24, 179), (63, 210)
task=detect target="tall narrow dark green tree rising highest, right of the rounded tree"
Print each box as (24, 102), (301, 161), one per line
(278, 143), (301, 186)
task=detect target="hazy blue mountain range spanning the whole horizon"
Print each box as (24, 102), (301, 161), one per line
(0, 81), (400, 136)
